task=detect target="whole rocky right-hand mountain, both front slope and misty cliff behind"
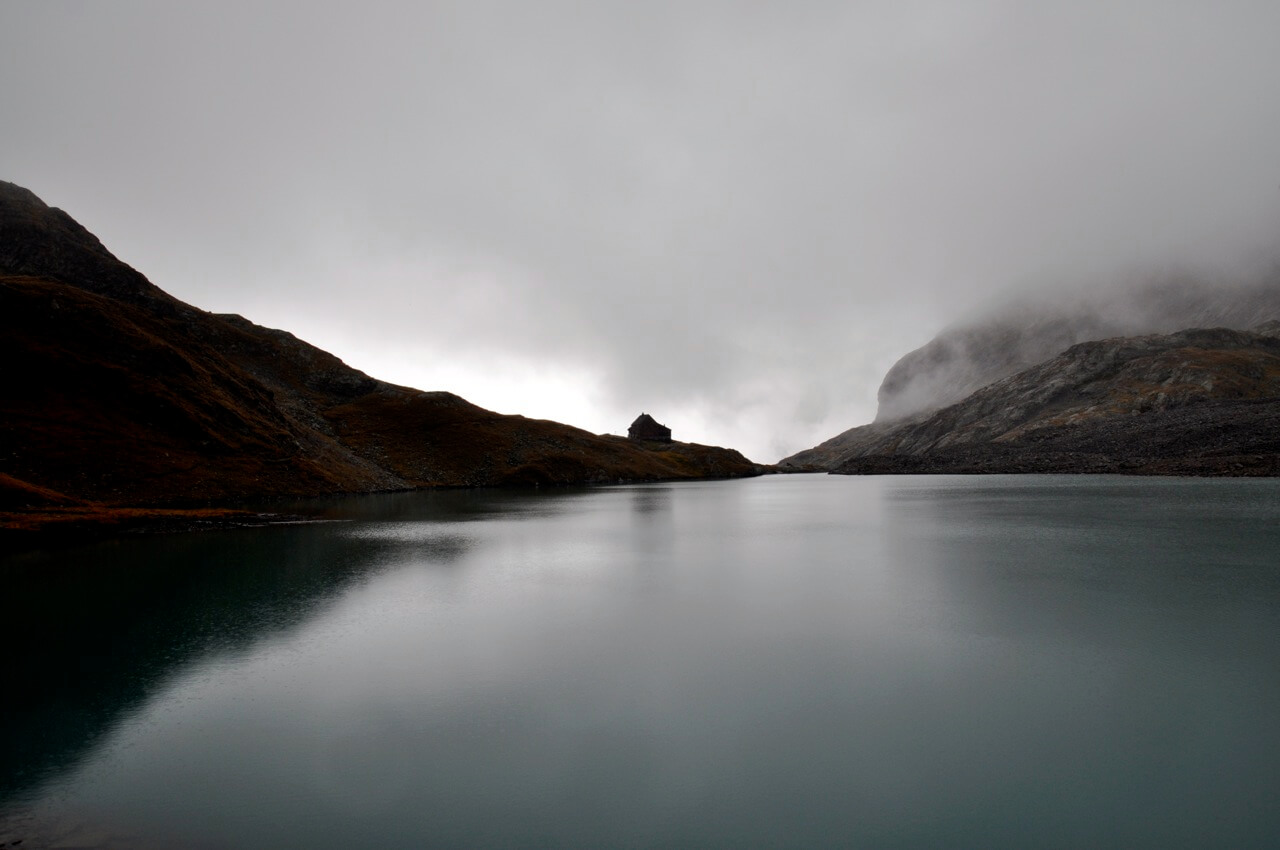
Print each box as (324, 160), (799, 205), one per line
(782, 266), (1280, 475)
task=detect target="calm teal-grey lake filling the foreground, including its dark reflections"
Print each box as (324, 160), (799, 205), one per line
(0, 475), (1280, 849)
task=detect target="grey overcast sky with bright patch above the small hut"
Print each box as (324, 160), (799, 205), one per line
(0, 0), (1280, 461)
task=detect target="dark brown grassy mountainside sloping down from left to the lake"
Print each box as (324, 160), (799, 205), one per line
(0, 183), (759, 524)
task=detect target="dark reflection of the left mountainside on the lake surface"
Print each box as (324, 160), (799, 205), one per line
(0, 497), (483, 804)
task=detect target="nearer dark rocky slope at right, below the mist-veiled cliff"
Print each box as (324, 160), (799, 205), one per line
(832, 323), (1280, 475)
